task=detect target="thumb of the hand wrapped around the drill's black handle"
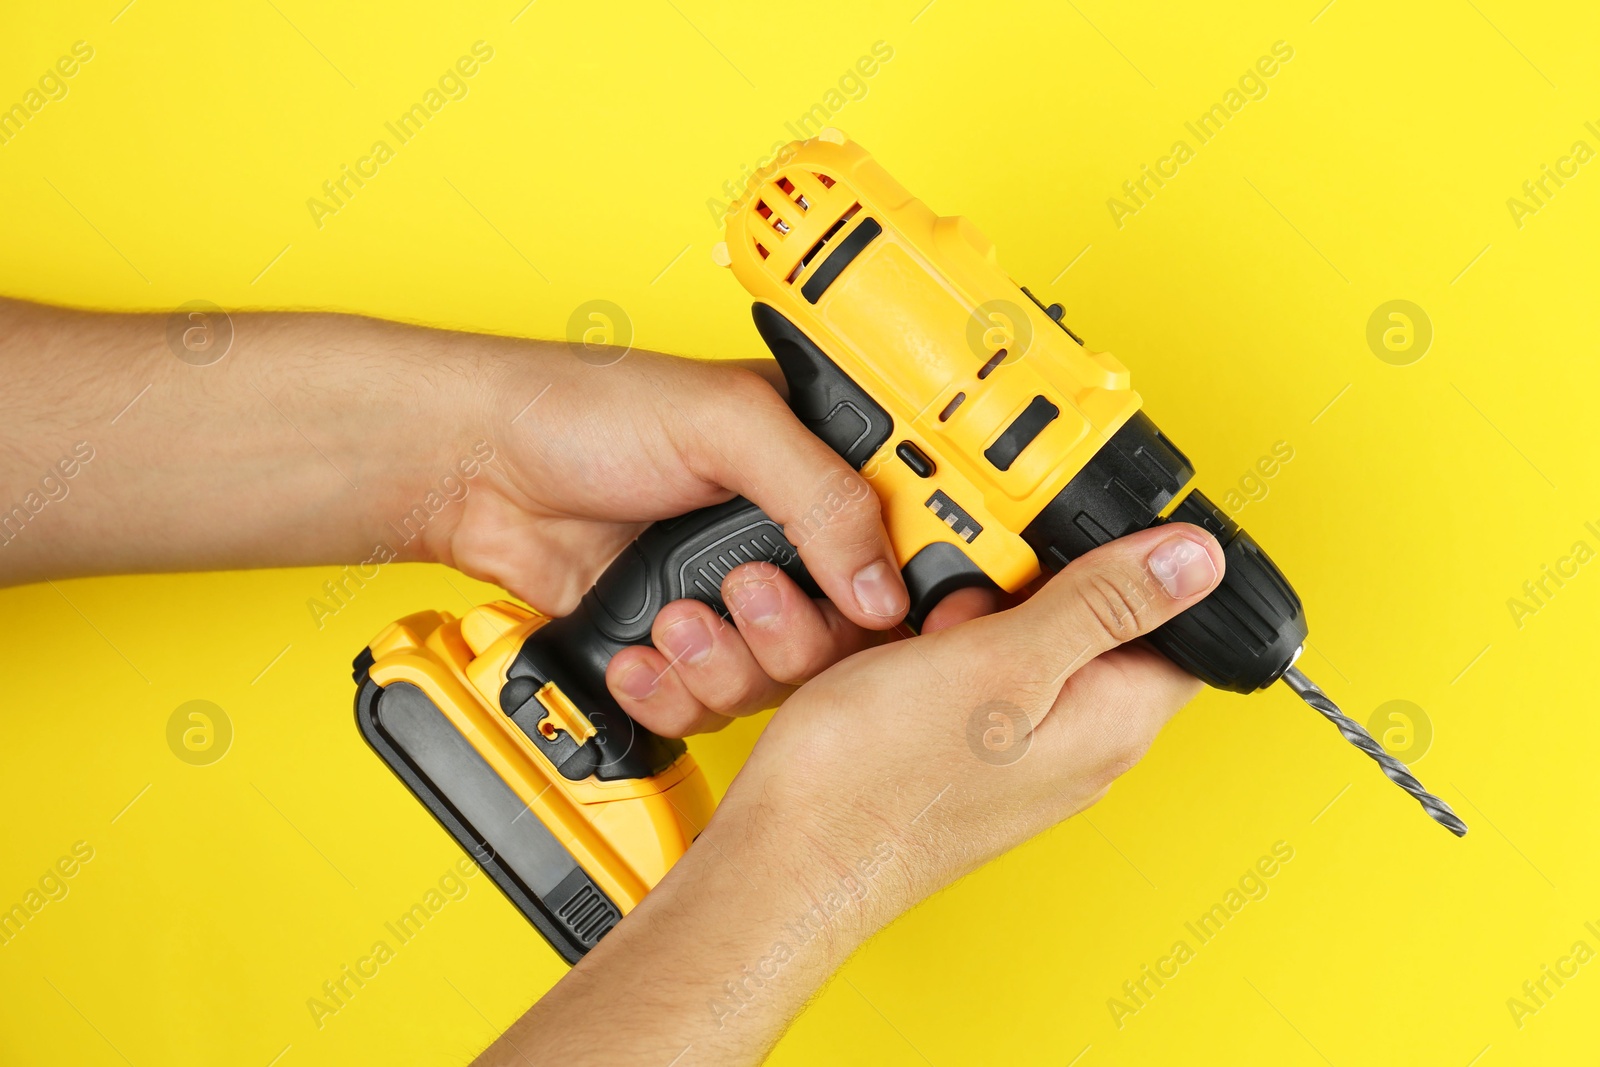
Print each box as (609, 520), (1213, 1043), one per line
(694, 373), (909, 630)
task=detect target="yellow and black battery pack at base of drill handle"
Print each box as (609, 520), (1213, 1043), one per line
(354, 601), (712, 963)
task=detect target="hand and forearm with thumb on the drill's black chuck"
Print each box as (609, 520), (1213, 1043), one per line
(478, 525), (1222, 1067)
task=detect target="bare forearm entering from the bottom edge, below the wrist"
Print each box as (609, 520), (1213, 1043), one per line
(475, 805), (906, 1067)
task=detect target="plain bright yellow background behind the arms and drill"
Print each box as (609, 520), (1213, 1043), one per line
(0, 0), (1600, 1067)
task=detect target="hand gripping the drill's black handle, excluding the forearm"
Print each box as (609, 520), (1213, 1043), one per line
(429, 347), (928, 736)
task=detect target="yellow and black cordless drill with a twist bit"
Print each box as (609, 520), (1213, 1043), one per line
(355, 131), (1466, 961)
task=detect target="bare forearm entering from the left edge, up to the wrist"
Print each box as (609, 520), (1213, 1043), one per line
(0, 301), (538, 584)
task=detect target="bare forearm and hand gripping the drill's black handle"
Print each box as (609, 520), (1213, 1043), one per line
(0, 299), (921, 736)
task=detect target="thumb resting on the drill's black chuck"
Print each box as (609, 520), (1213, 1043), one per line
(1011, 523), (1222, 673)
